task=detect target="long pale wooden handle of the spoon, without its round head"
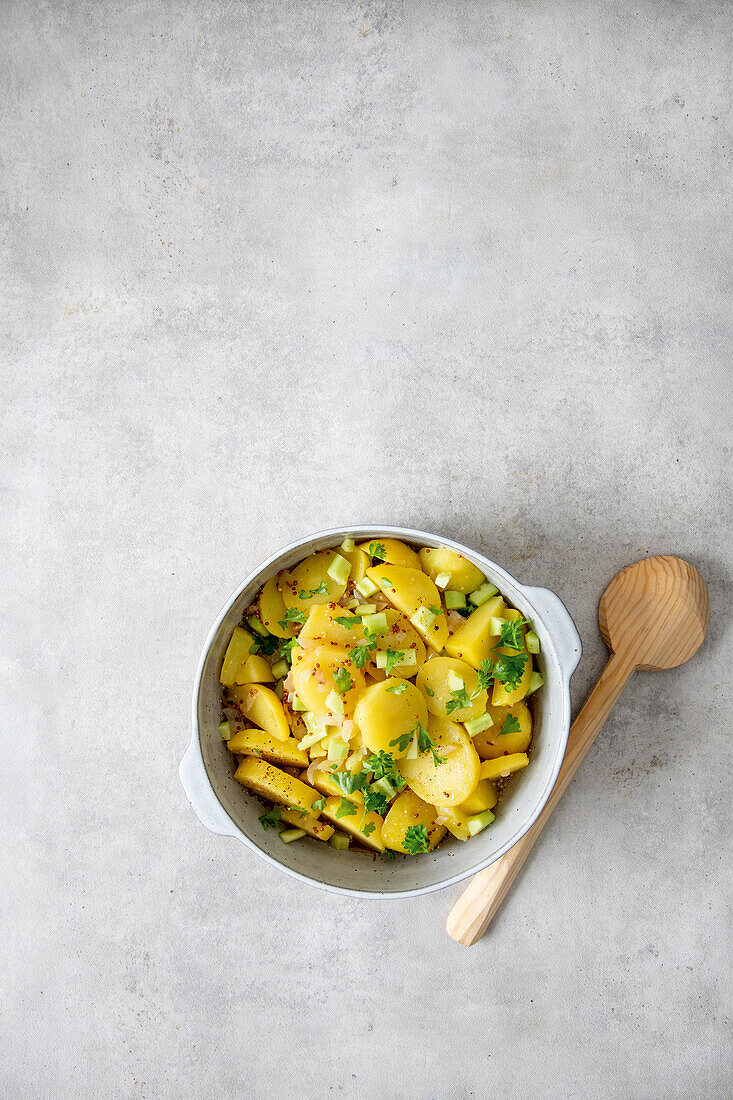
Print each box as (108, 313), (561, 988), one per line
(446, 653), (635, 947)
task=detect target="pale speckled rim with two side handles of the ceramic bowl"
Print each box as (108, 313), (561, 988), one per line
(179, 524), (581, 901)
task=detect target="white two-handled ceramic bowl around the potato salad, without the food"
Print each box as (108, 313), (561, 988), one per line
(180, 527), (580, 898)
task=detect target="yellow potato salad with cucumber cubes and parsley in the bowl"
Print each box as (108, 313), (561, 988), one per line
(219, 538), (543, 859)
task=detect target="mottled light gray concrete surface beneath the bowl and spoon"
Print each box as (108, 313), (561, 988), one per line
(0, 0), (733, 1100)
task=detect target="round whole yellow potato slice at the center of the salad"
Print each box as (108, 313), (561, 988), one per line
(353, 677), (427, 760)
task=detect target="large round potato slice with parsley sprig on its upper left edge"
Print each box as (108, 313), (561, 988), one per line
(400, 715), (481, 806)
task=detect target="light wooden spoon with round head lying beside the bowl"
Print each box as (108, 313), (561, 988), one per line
(447, 557), (710, 947)
